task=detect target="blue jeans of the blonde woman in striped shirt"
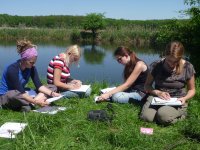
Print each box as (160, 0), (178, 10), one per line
(61, 88), (92, 98)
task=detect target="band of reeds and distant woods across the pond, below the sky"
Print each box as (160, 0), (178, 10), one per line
(0, 13), (194, 47)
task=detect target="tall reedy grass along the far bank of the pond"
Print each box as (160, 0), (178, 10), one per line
(0, 26), (159, 47)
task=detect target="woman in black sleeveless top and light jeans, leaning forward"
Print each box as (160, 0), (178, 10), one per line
(98, 46), (148, 103)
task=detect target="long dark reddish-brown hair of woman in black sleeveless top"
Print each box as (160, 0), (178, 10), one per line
(114, 46), (140, 80)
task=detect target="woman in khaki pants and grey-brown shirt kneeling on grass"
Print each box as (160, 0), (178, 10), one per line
(140, 41), (195, 125)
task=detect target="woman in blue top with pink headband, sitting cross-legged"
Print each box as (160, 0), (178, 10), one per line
(0, 40), (60, 111)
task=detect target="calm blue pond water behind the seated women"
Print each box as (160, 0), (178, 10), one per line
(0, 44), (159, 84)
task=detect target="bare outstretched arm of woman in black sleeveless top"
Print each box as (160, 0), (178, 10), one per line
(100, 61), (147, 99)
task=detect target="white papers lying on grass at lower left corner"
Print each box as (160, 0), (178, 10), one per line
(0, 122), (27, 138)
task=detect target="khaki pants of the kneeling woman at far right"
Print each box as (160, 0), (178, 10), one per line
(140, 96), (187, 125)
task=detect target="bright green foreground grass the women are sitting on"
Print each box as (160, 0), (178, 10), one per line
(0, 82), (200, 150)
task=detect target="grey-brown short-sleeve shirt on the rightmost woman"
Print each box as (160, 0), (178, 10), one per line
(150, 59), (195, 97)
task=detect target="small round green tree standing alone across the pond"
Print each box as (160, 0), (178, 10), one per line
(83, 13), (105, 39)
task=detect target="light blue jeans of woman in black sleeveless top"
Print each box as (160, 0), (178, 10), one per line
(112, 92), (142, 103)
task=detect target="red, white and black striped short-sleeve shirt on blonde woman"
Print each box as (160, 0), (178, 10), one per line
(47, 55), (70, 84)
